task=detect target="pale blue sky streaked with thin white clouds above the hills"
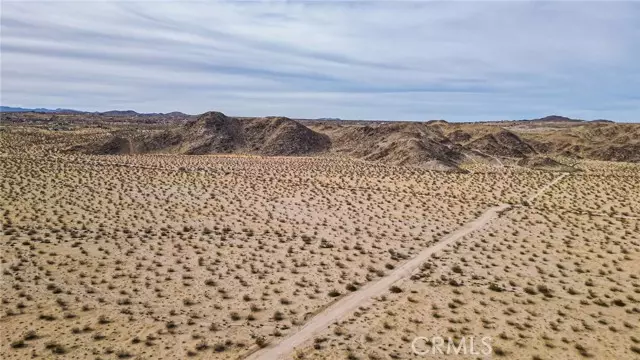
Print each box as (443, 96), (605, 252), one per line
(0, 0), (640, 122)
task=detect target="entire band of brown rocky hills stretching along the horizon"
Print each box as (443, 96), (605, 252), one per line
(7, 112), (640, 171)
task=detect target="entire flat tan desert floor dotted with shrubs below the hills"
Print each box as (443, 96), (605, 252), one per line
(0, 139), (640, 359)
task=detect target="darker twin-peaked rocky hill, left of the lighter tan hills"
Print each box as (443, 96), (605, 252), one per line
(73, 112), (330, 155)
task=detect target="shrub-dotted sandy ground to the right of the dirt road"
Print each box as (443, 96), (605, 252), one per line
(290, 163), (640, 359)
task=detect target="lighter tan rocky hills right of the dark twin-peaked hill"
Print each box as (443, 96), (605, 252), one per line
(304, 116), (640, 171)
